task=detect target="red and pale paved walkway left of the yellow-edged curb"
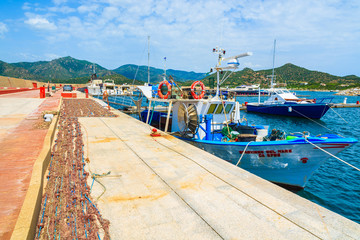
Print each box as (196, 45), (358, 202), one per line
(0, 90), (61, 239)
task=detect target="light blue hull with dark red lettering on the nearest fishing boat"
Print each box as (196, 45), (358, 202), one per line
(184, 139), (356, 189)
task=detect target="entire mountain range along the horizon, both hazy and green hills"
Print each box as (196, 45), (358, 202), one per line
(0, 57), (360, 89)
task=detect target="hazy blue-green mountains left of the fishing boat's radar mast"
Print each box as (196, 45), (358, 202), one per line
(0, 57), (205, 83)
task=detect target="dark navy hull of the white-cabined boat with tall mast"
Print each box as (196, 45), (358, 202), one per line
(246, 103), (330, 119)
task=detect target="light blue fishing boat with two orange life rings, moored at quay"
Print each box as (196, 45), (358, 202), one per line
(139, 48), (357, 189)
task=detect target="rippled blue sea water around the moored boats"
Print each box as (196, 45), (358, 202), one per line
(237, 91), (360, 223)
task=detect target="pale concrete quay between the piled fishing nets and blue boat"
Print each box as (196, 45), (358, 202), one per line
(79, 114), (360, 240)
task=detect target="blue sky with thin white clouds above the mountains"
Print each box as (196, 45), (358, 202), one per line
(0, 0), (360, 76)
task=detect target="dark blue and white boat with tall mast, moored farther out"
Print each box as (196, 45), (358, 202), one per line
(246, 40), (332, 119)
